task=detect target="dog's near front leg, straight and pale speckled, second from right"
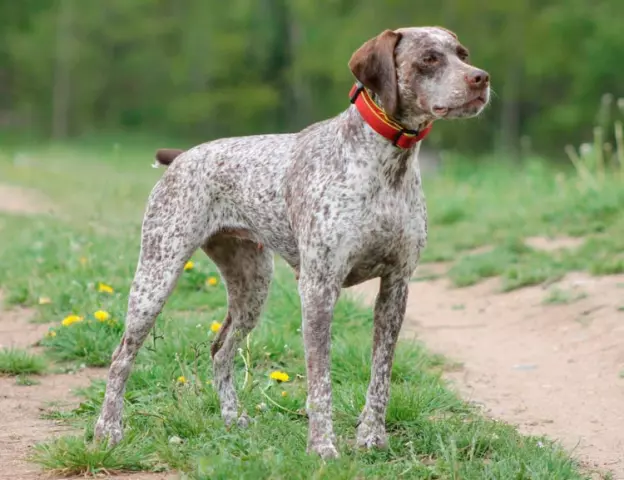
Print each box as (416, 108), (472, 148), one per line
(299, 271), (340, 459)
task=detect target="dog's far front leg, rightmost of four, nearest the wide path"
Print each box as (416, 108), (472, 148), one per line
(357, 277), (409, 448)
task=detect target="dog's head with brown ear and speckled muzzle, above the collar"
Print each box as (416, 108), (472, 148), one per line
(349, 27), (490, 129)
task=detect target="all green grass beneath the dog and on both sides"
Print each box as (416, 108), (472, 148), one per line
(0, 136), (608, 479)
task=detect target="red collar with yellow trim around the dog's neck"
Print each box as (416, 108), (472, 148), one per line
(349, 82), (433, 149)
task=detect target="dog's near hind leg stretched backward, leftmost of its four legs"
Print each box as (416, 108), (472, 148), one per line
(95, 174), (207, 445)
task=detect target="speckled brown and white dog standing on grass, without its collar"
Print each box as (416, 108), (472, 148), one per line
(95, 27), (490, 458)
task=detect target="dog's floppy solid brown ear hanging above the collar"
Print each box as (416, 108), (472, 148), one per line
(349, 30), (401, 115)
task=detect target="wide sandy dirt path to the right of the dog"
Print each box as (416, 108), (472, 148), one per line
(350, 265), (624, 479)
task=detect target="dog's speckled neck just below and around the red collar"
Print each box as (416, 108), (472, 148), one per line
(341, 105), (422, 188)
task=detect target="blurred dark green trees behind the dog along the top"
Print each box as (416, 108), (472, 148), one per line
(0, 0), (624, 157)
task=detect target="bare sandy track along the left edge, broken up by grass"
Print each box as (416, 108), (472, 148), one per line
(0, 185), (177, 480)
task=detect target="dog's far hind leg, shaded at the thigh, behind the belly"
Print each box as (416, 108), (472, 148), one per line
(204, 236), (273, 426)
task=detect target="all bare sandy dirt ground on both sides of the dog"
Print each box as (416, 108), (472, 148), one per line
(0, 185), (624, 480)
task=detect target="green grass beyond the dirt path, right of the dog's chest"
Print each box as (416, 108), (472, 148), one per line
(423, 157), (624, 291)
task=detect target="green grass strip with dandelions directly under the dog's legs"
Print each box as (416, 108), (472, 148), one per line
(26, 267), (581, 480)
